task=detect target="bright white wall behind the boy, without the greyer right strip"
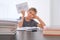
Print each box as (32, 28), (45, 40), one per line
(0, 0), (50, 26)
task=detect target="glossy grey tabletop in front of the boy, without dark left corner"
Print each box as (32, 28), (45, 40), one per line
(16, 30), (60, 40)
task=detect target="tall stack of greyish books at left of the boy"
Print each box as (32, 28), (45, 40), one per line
(0, 19), (17, 35)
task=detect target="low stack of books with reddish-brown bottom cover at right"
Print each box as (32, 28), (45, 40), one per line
(43, 26), (60, 36)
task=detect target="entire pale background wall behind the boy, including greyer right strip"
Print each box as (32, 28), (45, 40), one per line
(0, 0), (60, 27)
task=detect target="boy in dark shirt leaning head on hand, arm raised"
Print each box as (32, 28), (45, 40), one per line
(18, 8), (45, 28)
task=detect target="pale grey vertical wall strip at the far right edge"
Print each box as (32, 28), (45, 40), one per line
(51, 0), (60, 26)
